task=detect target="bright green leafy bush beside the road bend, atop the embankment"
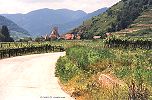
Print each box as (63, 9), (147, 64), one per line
(66, 46), (115, 70)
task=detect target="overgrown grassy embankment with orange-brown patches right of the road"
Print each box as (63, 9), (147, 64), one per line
(56, 42), (152, 100)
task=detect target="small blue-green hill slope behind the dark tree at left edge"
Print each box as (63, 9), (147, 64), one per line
(0, 16), (29, 38)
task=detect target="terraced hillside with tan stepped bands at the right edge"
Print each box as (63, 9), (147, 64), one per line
(113, 7), (152, 38)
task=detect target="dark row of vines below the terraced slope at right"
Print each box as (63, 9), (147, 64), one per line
(105, 37), (152, 50)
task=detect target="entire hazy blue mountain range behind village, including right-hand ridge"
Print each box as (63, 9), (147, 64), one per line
(3, 8), (107, 36)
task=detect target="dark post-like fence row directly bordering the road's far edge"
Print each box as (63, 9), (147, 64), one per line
(0, 45), (64, 59)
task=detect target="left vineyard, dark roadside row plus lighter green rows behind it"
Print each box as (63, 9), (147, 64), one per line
(0, 42), (64, 59)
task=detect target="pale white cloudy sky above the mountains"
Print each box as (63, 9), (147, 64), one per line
(0, 0), (120, 14)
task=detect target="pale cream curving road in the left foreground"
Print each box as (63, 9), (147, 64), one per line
(0, 52), (73, 100)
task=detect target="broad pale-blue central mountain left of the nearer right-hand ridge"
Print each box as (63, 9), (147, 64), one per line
(3, 8), (87, 35)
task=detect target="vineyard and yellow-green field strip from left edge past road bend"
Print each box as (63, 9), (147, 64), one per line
(0, 40), (103, 59)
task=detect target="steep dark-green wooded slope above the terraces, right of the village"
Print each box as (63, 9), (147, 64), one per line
(72, 0), (152, 39)
